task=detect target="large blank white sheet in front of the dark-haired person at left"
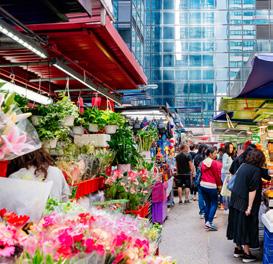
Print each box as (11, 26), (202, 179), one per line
(0, 178), (53, 221)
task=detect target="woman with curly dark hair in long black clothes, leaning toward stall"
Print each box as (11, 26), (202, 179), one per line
(227, 149), (265, 263)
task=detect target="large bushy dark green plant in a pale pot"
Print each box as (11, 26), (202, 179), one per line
(108, 127), (140, 172)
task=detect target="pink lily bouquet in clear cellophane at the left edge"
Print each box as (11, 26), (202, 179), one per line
(0, 94), (41, 160)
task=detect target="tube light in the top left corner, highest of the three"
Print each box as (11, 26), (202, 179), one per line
(0, 19), (48, 59)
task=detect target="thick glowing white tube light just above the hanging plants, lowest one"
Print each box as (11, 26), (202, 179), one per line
(0, 80), (53, 105)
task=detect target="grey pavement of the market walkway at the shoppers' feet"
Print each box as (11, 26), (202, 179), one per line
(160, 202), (262, 264)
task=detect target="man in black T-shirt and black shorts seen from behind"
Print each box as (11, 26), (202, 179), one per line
(176, 144), (194, 204)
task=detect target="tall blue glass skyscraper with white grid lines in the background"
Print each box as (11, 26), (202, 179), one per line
(113, 0), (273, 127)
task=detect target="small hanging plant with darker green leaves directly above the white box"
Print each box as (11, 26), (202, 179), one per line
(83, 107), (105, 133)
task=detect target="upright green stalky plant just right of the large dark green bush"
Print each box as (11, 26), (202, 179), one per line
(137, 126), (158, 152)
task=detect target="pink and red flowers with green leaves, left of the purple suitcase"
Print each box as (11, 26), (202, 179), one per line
(105, 169), (154, 210)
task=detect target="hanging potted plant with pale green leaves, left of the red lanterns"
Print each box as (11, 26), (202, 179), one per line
(55, 93), (79, 127)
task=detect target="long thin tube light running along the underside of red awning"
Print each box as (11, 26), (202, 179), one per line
(53, 60), (121, 105)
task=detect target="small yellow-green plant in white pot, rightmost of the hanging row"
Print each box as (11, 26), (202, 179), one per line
(102, 110), (126, 134)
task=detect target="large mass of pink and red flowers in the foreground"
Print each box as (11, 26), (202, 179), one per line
(0, 202), (173, 264)
